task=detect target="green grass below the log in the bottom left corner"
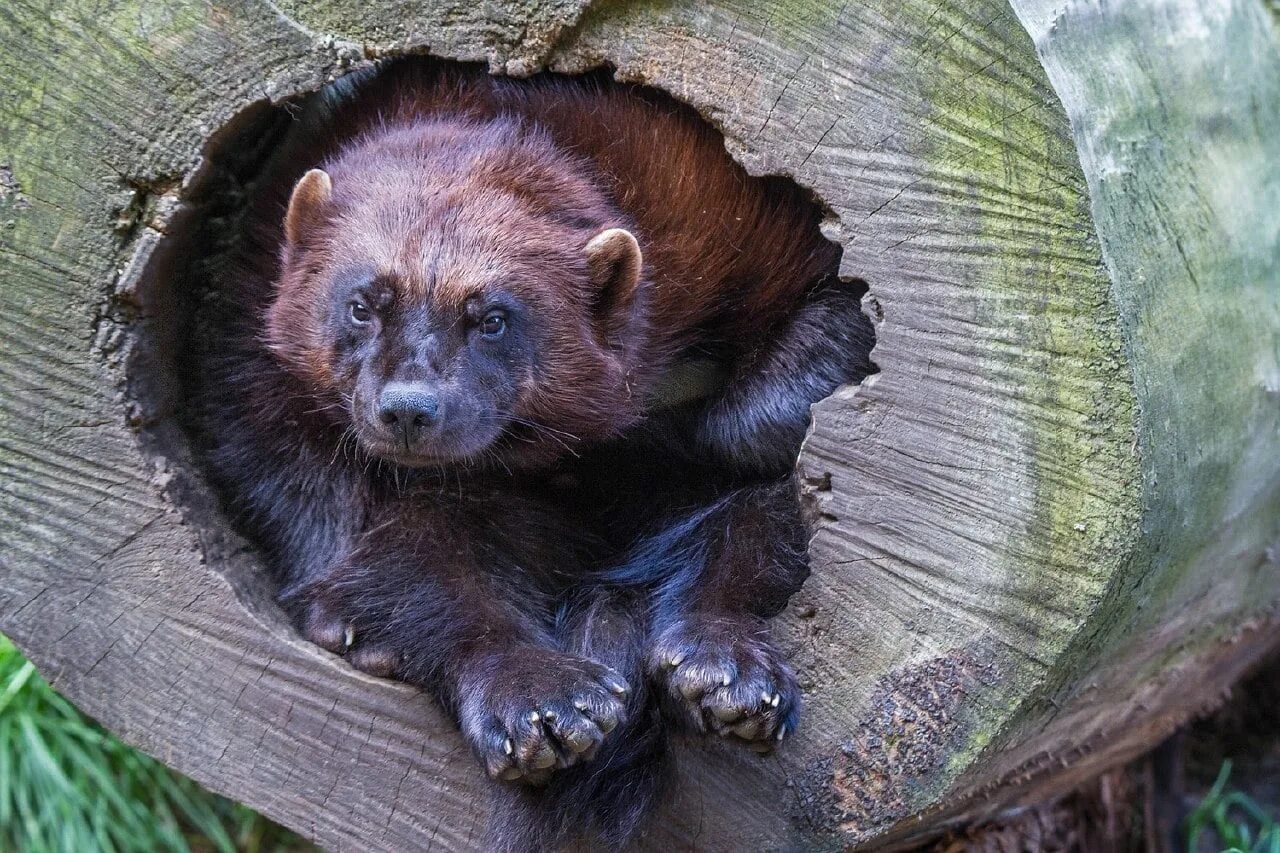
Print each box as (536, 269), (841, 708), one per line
(0, 637), (310, 853)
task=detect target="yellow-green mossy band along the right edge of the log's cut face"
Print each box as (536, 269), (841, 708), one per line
(901, 3), (1139, 802)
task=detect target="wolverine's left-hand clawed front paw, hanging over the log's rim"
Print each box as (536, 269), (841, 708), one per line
(458, 648), (631, 784)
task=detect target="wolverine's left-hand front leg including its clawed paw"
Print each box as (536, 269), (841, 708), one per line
(294, 484), (631, 783)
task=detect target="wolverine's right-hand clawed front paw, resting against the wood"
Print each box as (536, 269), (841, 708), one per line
(649, 616), (800, 753)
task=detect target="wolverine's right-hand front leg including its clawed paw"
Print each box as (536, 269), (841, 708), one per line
(620, 478), (809, 749)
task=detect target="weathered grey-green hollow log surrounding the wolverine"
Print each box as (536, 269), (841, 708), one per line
(0, 0), (1280, 850)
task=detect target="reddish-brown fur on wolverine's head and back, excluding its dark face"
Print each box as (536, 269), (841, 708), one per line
(268, 65), (837, 466)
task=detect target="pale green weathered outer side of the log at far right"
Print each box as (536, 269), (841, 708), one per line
(1016, 0), (1280, 676)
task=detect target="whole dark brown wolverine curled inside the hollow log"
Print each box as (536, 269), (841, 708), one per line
(196, 60), (873, 850)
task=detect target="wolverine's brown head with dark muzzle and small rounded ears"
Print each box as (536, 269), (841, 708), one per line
(266, 120), (644, 466)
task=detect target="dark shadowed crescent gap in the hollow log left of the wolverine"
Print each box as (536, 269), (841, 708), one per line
(121, 94), (309, 631)
